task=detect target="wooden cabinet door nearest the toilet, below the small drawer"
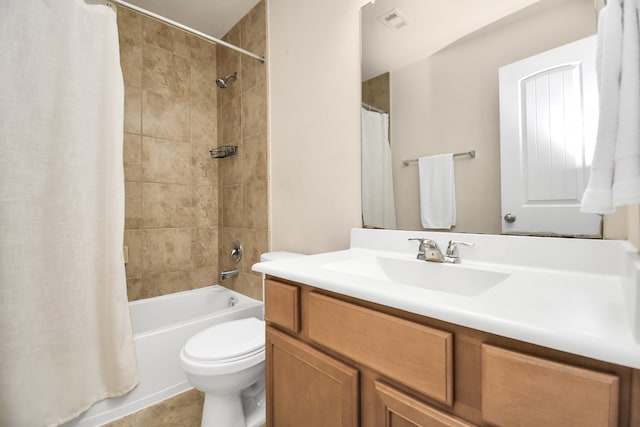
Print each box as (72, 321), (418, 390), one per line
(266, 327), (359, 427)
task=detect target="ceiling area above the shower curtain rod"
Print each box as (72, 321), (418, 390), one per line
(124, 0), (260, 39)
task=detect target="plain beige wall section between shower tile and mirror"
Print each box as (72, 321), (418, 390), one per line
(268, 0), (364, 253)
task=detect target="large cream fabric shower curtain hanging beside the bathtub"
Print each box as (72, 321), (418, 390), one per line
(0, 0), (138, 426)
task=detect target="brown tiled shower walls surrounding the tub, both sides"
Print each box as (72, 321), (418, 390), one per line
(118, 2), (268, 300)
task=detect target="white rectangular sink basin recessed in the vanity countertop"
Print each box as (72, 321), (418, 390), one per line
(322, 256), (509, 296)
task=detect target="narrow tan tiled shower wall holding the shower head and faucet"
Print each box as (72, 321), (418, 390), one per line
(218, 0), (269, 299)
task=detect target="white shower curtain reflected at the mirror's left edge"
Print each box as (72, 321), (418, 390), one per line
(362, 108), (396, 230)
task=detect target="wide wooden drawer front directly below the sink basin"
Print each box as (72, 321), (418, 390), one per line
(308, 292), (453, 405)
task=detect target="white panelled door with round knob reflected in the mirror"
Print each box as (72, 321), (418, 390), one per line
(499, 36), (602, 237)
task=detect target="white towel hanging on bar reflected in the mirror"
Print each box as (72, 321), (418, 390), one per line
(418, 153), (456, 229)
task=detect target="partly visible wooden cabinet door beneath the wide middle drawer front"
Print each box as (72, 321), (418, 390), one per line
(375, 381), (473, 427)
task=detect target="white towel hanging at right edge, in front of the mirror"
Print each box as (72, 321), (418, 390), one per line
(581, 0), (640, 214)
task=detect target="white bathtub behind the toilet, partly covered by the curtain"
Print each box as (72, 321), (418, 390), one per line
(62, 285), (263, 427)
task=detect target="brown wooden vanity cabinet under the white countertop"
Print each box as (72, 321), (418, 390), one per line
(265, 277), (640, 427)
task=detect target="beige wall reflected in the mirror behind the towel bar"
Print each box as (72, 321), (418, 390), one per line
(391, 0), (596, 234)
